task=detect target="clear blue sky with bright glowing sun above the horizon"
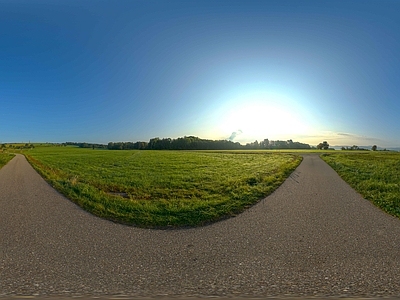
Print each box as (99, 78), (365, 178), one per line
(0, 0), (400, 147)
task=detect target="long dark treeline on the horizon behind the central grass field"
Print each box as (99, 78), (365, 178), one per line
(107, 136), (311, 150)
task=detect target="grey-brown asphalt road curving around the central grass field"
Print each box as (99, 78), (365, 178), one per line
(0, 155), (400, 298)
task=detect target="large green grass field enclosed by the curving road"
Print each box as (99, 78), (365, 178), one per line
(24, 147), (301, 227)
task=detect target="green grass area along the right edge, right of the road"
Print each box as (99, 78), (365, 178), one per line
(322, 151), (400, 218)
